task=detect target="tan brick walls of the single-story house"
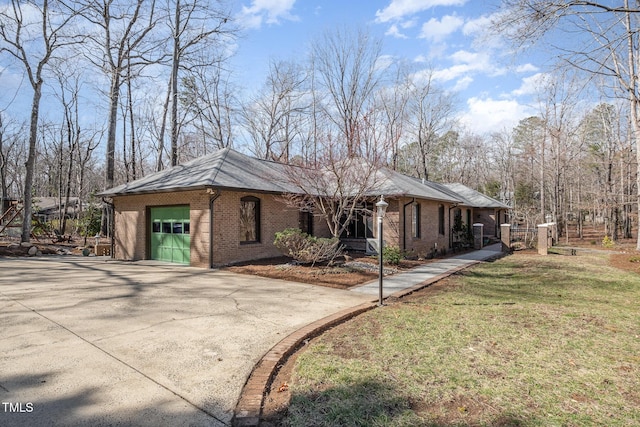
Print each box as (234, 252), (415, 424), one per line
(114, 190), (466, 268)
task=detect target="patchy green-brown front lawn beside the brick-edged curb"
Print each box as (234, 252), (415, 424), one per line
(266, 254), (640, 427)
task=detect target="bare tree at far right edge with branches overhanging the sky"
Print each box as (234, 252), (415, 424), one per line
(493, 0), (640, 250)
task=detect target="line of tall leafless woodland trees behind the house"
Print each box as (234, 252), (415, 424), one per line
(0, 0), (639, 249)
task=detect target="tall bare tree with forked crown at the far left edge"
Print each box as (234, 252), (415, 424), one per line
(0, 0), (78, 242)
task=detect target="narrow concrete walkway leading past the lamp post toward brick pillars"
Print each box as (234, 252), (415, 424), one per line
(351, 243), (502, 298)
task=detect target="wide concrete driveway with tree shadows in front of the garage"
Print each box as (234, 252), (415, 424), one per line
(0, 257), (371, 426)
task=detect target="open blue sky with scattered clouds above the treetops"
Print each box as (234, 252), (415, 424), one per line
(234, 0), (544, 133)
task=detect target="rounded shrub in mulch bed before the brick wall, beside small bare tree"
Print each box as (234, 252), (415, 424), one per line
(273, 228), (343, 265)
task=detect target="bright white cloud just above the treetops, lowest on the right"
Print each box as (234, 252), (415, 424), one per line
(460, 97), (533, 134)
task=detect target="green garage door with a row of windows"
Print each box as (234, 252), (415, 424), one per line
(151, 206), (191, 265)
